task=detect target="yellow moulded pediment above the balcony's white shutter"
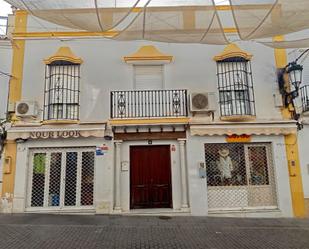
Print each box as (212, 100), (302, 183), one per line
(124, 45), (173, 62)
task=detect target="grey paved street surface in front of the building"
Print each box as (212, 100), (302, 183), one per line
(0, 214), (309, 249)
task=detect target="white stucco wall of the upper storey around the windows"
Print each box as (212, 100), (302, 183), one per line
(22, 39), (281, 121)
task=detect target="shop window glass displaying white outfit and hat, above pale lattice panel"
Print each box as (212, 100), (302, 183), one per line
(205, 144), (269, 186)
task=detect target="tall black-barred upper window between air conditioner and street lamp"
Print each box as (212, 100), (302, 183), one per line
(217, 57), (255, 117)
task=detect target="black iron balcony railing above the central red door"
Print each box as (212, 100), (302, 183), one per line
(111, 90), (188, 119)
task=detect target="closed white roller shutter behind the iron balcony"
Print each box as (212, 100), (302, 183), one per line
(134, 65), (163, 90)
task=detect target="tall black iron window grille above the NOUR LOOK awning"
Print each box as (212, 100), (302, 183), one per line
(44, 61), (80, 120)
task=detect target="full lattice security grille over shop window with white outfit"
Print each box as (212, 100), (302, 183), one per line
(205, 143), (277, 211)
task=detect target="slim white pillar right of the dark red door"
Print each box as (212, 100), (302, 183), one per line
(178, 139), (189, 209)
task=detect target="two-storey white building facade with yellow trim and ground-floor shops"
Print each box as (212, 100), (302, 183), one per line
(2, 11), (305, 217)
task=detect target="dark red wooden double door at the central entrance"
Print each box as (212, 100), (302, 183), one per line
(130, 145), (172, 209)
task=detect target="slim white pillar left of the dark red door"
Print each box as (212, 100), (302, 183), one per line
(114, 141), (122, 211)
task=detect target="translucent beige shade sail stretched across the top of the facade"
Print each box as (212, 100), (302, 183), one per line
(6, 0), (309, 47)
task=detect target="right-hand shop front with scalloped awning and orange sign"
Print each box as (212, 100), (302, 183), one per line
(187, 122), (296, 217)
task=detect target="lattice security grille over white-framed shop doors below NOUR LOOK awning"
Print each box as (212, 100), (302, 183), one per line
(28, 148), (95, 210)
